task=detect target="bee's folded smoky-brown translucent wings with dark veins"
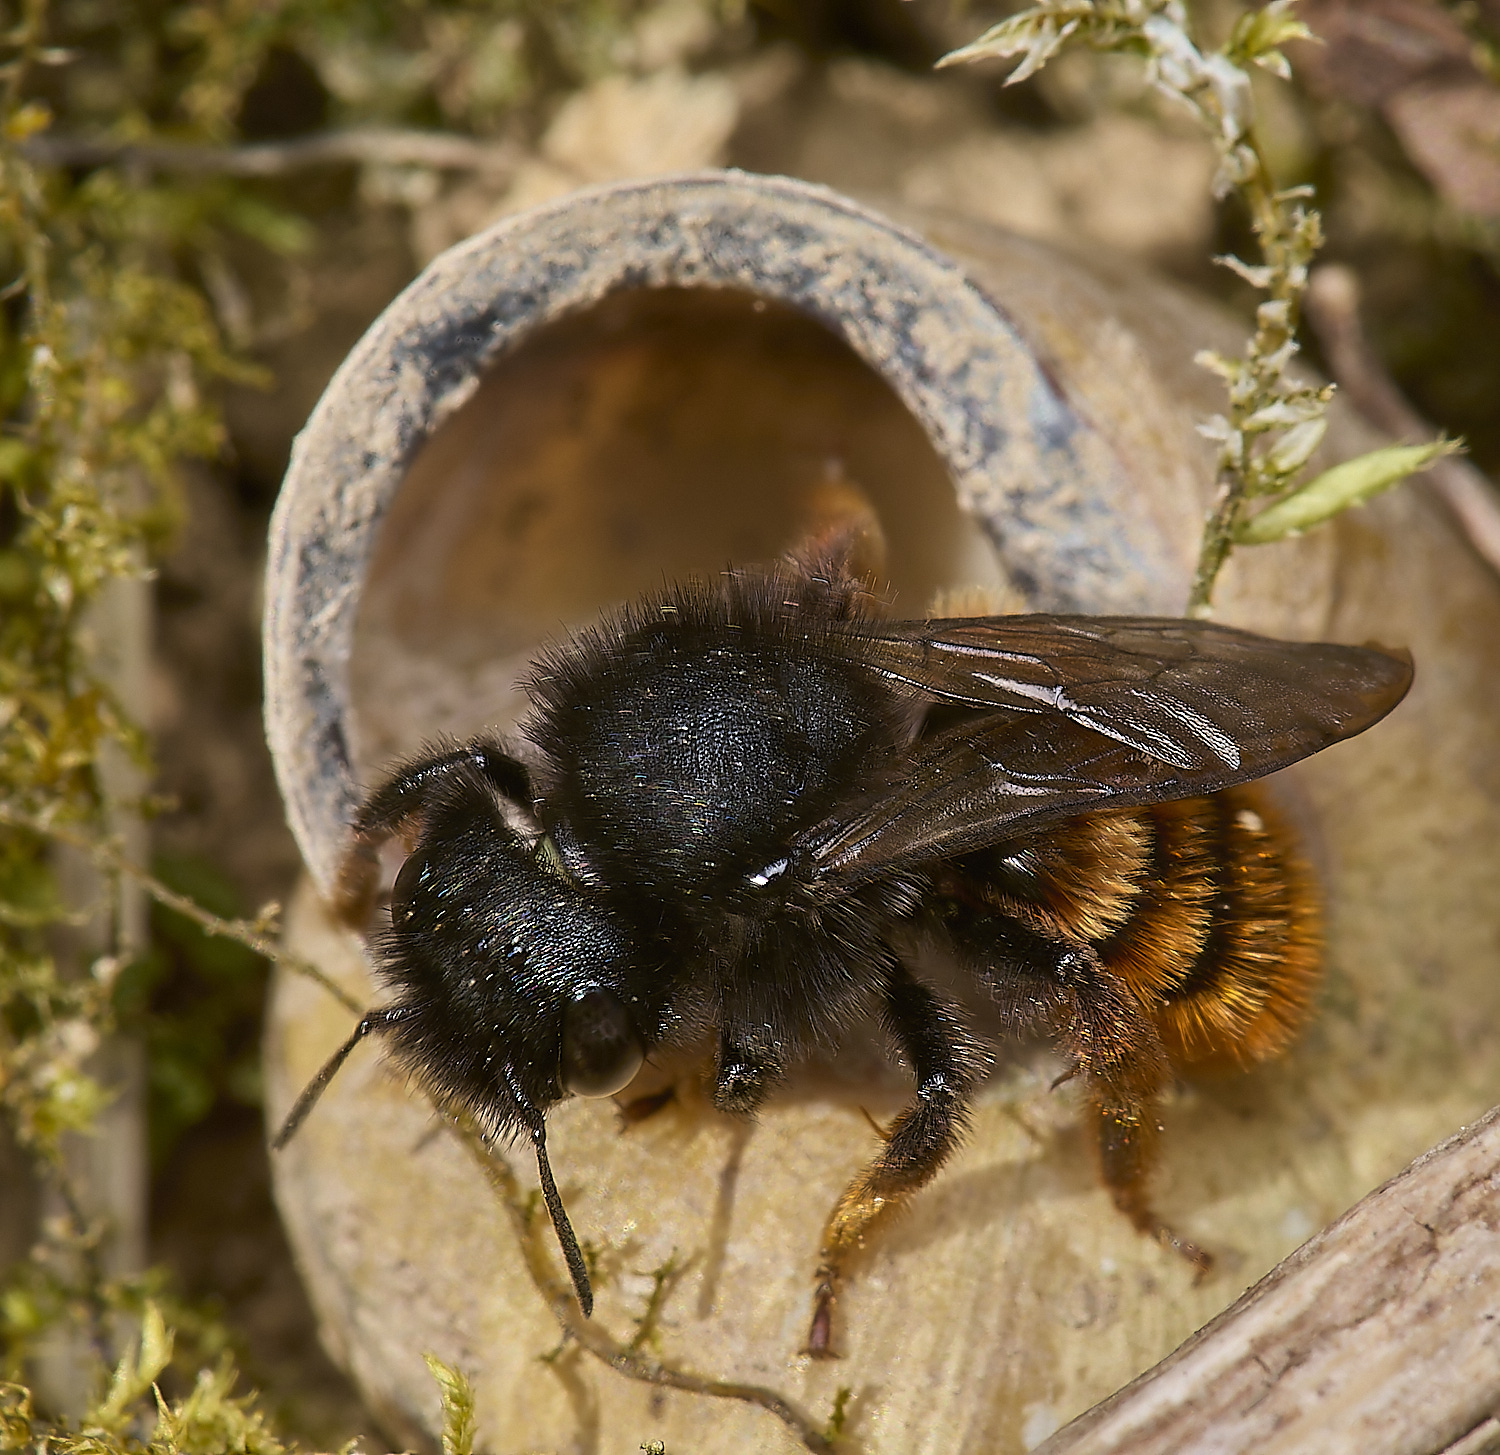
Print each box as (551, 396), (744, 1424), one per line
(803, 617), (1412, 879)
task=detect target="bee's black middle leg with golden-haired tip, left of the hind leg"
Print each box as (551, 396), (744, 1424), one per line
(807, 963), (984, 1359)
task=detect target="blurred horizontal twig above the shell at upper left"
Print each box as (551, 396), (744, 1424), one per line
(20, 126), (519, 177)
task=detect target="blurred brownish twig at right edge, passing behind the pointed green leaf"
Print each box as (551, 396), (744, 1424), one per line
(1307, 263), (1500, 572)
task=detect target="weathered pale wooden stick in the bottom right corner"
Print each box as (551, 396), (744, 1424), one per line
(1038, 1107), (1500, 1455)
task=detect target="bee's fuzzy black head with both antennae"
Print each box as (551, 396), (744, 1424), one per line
(275, 792), (668, 1314)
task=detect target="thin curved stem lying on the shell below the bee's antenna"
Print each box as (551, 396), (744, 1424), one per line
(449, 1118), (833, 1455)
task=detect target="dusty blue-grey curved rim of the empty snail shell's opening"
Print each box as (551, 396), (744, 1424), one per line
(266, 173), (1181, 890)
